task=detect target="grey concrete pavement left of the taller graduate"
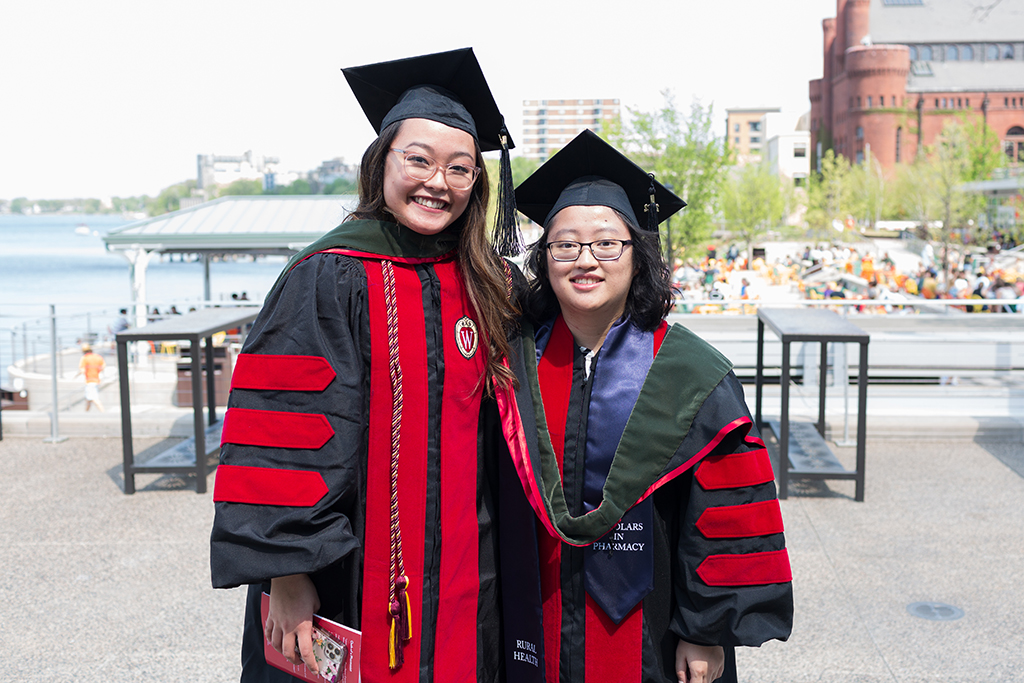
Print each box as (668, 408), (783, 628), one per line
(0, 434), (244, 683)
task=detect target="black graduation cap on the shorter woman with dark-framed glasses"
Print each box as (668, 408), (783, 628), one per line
(515, 130), (686, 232)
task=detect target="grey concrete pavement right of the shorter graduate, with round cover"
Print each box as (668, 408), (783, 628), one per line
(737, 439), (1024, 683)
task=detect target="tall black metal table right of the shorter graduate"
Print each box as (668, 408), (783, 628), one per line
(755, 308), (870, 501)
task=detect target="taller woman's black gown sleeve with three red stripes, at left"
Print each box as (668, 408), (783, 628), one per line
(210, 254), (370, 588)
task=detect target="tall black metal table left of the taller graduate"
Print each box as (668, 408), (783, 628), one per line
(117, 307), (259, 494)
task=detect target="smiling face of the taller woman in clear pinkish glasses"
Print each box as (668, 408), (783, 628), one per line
(384, 119), (476, 234)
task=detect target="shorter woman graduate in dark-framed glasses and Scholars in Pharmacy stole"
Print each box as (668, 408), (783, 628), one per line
(500, 131), (793, 683)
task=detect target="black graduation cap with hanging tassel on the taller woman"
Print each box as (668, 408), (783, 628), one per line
(342, 47), (522, 256)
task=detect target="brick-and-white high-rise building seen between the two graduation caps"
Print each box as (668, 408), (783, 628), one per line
(517, 99), (618, 159)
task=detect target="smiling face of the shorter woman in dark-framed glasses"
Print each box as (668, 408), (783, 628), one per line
(546, 206), (634, 330)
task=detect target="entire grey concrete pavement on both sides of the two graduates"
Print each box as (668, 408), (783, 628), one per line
(0, 433), (1024, 683)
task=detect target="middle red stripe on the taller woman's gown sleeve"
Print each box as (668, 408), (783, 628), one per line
(220, 408), (334, 450)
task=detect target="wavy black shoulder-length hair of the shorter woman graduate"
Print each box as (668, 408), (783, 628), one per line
(526, 209), (676, 332)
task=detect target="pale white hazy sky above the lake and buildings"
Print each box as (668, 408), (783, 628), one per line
(0, 0), (836, 199)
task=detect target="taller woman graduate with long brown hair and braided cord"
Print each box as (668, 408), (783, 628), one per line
(211, 49), (515, 683)
